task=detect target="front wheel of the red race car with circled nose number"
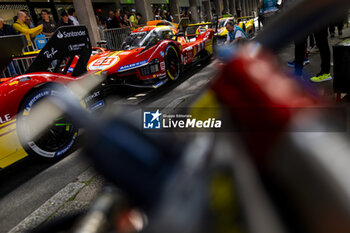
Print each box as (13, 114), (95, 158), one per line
(165, 45), (180, 80)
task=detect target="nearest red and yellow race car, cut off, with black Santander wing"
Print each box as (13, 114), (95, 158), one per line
(0, 26), (100, 168)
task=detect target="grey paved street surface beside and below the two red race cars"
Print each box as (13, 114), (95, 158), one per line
(0, 57), (219, 232)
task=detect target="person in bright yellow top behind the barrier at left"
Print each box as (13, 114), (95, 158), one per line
(12, 11), (43, 51)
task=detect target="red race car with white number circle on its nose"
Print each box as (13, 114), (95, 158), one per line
(88, 23), (214, 88)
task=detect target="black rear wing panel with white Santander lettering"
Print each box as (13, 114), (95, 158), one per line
(26, 26), (92, 77)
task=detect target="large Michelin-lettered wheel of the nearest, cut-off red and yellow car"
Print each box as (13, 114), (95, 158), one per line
(17, 86), (78, 159)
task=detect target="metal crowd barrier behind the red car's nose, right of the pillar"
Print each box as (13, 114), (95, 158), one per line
(102, 28), (131, 50)
